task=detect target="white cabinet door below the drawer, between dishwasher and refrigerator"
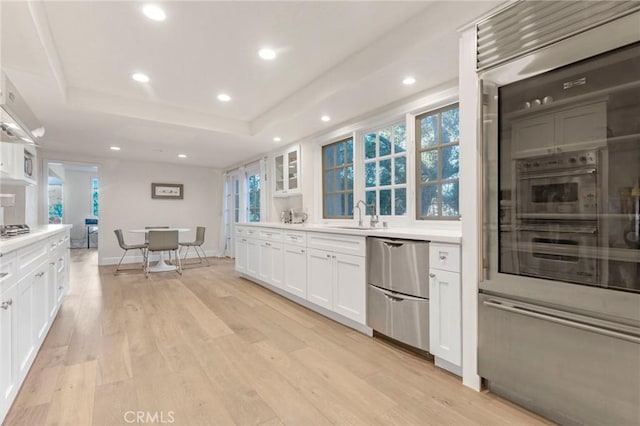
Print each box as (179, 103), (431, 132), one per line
(429, 269), (462, 365)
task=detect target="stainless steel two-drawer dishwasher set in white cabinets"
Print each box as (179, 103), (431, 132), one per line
(367, 237), (429, 351)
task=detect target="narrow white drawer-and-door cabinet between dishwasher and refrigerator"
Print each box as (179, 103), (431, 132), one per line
(429, 243), (462, 375)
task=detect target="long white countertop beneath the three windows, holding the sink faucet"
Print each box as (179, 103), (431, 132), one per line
(236, 222), (462, 244)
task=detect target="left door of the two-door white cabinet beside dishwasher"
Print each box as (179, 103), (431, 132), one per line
(307, 249), (333, 309)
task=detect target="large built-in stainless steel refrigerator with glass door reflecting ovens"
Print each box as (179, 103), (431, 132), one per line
(477, 2), (640, 424)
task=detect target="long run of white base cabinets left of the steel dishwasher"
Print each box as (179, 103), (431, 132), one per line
(236, 226), (366, 327)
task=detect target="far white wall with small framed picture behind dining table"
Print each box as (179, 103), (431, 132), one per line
(39, 151), (223, 264)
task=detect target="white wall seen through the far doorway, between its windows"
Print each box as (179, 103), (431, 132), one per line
(62, 170), (98, 247)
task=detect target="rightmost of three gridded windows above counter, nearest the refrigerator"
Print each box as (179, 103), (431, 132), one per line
(416, 104), (460, 219)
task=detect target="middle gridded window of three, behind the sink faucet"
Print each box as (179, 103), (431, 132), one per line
(364, 123), (407, 216)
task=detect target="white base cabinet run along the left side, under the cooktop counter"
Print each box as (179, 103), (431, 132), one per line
(0, 230), (69, 423)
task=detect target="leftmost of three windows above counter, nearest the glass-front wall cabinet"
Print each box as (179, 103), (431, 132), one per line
(322, 138), (353, 219)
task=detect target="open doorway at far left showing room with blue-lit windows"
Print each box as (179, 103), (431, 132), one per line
(46, 161), (100, 249)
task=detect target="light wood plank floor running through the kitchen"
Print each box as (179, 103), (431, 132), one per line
(5, 250), (544, 426)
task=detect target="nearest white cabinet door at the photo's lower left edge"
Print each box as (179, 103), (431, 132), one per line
(0, 286), (18, 420)
